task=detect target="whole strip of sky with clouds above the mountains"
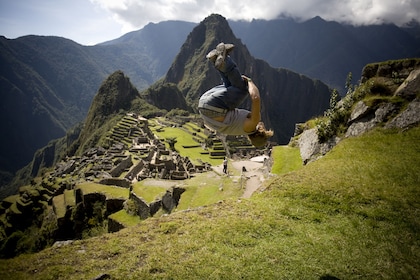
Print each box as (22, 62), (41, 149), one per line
(0, 0), (420, 45)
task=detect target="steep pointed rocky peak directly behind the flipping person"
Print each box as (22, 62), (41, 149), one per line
(154, 14), (330, 144)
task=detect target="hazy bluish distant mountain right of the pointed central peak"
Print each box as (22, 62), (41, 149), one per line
(229, 17), (420, 95)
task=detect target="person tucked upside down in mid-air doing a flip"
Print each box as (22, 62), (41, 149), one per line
(198, 43), (273, 147)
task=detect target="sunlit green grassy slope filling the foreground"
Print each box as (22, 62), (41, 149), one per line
(0, 128), (420, 279)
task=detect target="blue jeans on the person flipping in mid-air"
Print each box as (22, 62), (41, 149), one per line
(198, 56), (249, 111)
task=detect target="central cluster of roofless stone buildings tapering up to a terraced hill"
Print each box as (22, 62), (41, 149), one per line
(52, 114), (211, 187)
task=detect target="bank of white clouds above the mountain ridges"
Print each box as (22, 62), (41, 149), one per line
(90, 0), (420, 32)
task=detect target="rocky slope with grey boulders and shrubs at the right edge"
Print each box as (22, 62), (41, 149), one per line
(293, 59), (420, 164)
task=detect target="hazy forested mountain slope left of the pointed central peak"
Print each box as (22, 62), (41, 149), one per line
(0, 22), (194, 179)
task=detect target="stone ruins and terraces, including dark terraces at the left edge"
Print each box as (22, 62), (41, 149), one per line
(0, 114), (217, 249)
